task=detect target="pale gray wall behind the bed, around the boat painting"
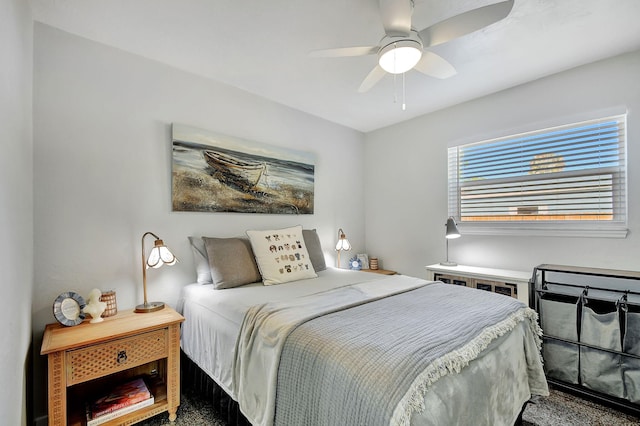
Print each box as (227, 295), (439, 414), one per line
(33, 24), (365, 422)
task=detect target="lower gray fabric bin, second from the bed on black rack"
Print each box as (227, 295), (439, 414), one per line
(580, 346), (625, 398)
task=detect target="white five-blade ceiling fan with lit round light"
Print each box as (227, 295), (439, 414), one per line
(310, 0), (514, 92)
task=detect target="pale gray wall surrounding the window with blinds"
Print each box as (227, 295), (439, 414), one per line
(365, 52), (640, 277)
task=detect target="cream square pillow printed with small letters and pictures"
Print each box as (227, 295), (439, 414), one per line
(247, 226), (318, 285)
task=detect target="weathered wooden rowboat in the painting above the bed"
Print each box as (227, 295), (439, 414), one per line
(204, 149), (267, 191)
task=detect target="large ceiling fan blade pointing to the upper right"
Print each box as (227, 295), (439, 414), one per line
(419, 0), (514, 47)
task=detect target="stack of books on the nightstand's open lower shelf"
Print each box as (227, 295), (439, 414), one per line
(87, 377), (153, 426)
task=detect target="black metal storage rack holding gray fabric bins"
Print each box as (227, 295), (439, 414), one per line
(529, 264), (640, 416)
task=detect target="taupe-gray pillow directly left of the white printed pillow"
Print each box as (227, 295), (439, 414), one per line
(202, 237), (262, 289)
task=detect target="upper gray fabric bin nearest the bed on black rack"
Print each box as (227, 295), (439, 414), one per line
(540, 294), (579, 342)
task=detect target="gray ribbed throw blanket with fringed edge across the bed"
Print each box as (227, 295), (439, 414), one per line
(275, 284), (535, 426)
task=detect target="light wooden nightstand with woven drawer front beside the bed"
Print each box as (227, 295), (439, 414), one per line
(40, 307), (184, 426)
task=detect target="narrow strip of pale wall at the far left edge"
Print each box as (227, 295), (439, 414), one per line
(0, 0), (33, 425)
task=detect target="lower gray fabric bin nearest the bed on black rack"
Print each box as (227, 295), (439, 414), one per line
(542, 337), (580, 384)
